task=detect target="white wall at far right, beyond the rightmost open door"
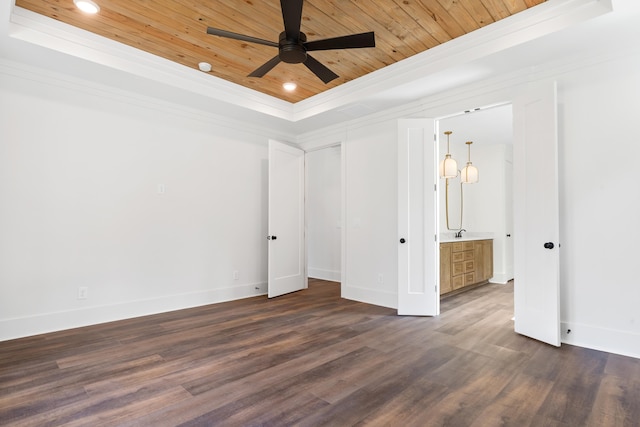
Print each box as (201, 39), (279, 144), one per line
(558, 50), (640, 357)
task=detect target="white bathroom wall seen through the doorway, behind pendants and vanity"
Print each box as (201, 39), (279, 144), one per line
(436, 104), (514, 300)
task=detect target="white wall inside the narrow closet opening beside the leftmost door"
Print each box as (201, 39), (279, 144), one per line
(306, 145), (342, 281)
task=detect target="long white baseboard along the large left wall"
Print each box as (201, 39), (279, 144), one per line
(0, 283), (267, 341)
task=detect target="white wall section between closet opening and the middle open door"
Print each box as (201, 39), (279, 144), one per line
(342, 120), (398, 307)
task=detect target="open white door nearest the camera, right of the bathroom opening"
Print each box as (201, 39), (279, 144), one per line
(513, 82), (560, 346)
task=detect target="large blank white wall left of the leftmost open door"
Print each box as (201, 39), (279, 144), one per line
(0, 64), (267, 340)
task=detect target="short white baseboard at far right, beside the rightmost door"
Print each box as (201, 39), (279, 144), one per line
(560, 322), (640, 359)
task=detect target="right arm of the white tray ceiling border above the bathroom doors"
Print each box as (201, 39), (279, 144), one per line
(293, 0), (613, 121)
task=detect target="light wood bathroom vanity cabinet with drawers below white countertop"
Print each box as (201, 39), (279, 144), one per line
(440, 239), (493, 294)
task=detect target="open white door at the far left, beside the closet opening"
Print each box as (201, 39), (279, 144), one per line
(267, 140), (307, 298)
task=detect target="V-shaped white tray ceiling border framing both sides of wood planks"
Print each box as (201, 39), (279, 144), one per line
(8, 0), (612, 122)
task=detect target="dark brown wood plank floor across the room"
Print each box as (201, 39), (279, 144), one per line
(0, 281), (640, 427)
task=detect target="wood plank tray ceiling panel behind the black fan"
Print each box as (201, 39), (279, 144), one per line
(16, 0), (546, 103)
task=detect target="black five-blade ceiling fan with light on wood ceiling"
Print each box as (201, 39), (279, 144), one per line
(207, 0), (376, 83)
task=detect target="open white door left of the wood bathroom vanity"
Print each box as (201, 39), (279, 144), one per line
(398, 119), (440, 316)
